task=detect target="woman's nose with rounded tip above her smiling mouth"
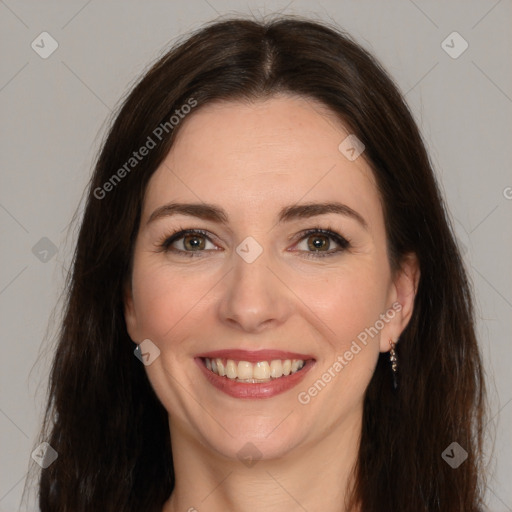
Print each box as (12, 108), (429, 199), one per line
(218, 243), (292, 333)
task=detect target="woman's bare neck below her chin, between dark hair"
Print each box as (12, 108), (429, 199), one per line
(162, 411), (362, 512)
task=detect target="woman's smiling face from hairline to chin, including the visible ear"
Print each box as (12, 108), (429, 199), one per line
(125, 96), (417, 458)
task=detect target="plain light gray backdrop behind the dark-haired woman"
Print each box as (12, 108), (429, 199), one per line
(0, 0), (512, 512)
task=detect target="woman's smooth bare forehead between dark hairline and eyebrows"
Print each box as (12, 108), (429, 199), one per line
(143, 96), (380, 226)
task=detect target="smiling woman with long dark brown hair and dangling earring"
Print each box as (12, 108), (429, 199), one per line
(32, 14), (485, 512)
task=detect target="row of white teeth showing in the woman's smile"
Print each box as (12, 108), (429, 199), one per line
(201, 357), (305, 382)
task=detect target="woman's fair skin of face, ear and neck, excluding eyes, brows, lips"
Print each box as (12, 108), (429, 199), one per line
(125, 95), (419, 512)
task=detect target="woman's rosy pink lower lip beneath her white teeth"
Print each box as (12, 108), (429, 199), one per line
(195, 358), (315, 398)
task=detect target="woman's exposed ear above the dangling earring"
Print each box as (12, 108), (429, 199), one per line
(380, 253), (420, 352)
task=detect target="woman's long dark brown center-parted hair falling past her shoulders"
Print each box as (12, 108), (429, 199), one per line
(29, 16), (486, 512)
